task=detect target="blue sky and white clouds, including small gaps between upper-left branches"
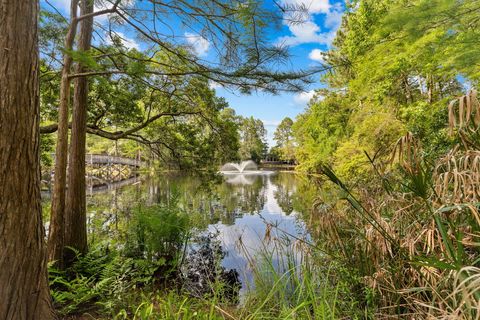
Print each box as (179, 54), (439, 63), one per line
(41, 0), (345, 146)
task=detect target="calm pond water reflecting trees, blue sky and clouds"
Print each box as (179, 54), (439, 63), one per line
(82, 172), (315, 291)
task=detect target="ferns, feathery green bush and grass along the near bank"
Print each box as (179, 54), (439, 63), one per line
(50, 201), (366, 320)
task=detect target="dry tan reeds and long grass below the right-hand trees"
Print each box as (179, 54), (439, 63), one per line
(314, 91), (480, 319)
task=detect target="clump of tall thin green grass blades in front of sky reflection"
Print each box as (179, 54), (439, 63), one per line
(234, 232), (342, 319)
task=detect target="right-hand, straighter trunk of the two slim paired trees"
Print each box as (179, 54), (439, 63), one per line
(64, 0), (94, 263)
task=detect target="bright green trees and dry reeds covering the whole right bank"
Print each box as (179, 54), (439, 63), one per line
(293, 0), (480, 319)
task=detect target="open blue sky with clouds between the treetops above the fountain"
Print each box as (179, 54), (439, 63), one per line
(217, 0), (344, 146)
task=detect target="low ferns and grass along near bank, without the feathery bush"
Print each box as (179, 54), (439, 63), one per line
(50, 219), (363, 320)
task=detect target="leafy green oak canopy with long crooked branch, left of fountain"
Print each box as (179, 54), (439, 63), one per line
(40, 39), (239, 170)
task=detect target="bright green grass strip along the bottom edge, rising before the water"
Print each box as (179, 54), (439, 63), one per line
(113, 228), (365, 320)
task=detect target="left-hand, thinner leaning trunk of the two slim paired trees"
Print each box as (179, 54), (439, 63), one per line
(48, 0), (79, 268)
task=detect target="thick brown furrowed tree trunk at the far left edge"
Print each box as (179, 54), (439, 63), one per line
(0, 0), (54, 319)
